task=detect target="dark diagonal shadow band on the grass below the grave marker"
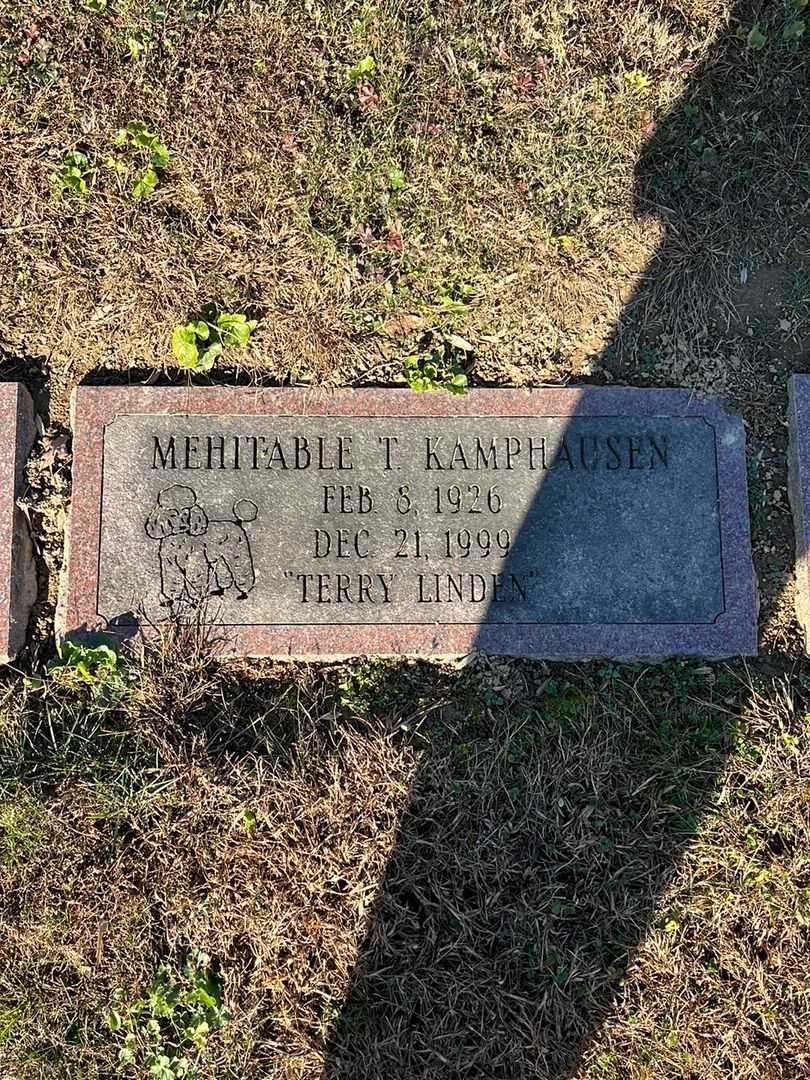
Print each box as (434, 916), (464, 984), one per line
(323, 661), (740, 1080)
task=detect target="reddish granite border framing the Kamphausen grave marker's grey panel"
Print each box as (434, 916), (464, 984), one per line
(57, 386), (758, 661)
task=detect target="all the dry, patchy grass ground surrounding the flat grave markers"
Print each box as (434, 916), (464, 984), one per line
(0, 0), (810, 1080)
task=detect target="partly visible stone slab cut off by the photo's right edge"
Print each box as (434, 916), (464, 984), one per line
(787, 375), (810, 652)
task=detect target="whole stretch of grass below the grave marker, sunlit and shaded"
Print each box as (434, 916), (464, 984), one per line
(0, 649), (810, 1080)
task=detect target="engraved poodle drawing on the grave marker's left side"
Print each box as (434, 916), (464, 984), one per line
(146, 484), (258, 605)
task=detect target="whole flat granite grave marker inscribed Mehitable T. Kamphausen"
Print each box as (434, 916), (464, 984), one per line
(60, 387), (756, 658)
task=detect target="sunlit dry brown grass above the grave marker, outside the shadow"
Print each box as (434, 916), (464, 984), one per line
(0, 0), (726, 420)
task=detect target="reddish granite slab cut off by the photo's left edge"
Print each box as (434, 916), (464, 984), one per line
(0, 382), (37, 663)
